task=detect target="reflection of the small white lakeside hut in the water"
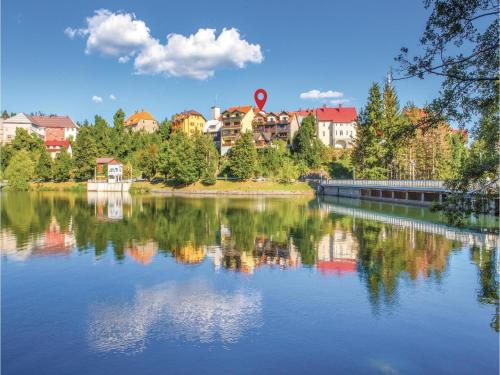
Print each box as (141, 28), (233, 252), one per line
(87, 191), (132, 220)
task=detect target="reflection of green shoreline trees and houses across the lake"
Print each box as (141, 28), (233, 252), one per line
(1, 193), (499, 330)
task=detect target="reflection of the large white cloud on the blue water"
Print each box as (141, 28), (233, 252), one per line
(89, 281), (262, 352)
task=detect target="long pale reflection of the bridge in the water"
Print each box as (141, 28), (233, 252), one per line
(320, 202), (498, 248)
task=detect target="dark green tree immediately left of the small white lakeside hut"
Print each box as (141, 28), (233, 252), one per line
(73, 126), (97, 181)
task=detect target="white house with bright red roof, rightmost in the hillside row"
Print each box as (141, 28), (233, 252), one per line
(295, 104), (358, 149)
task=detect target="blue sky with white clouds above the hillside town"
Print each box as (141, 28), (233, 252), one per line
(1, 0), (439, 121)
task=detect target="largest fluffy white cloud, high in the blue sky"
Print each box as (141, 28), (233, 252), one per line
(65, 9), (264, 79)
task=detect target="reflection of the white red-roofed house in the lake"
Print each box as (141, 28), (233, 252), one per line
(316, 229), (359, 274)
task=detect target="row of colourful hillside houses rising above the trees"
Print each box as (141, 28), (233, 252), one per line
(0, 105), (357, 155)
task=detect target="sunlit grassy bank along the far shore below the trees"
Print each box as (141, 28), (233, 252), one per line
(22, 181), (314, 194)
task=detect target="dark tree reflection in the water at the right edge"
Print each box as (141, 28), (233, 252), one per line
(471, 246), (499, 332)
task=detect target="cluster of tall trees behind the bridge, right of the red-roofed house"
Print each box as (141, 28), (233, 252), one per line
(352, 83), (468, 180)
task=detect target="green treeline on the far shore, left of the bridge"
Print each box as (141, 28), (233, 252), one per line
(0, 109), (325, 190)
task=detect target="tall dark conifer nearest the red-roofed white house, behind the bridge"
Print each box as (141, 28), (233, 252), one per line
(353, 83), (387, 179)
